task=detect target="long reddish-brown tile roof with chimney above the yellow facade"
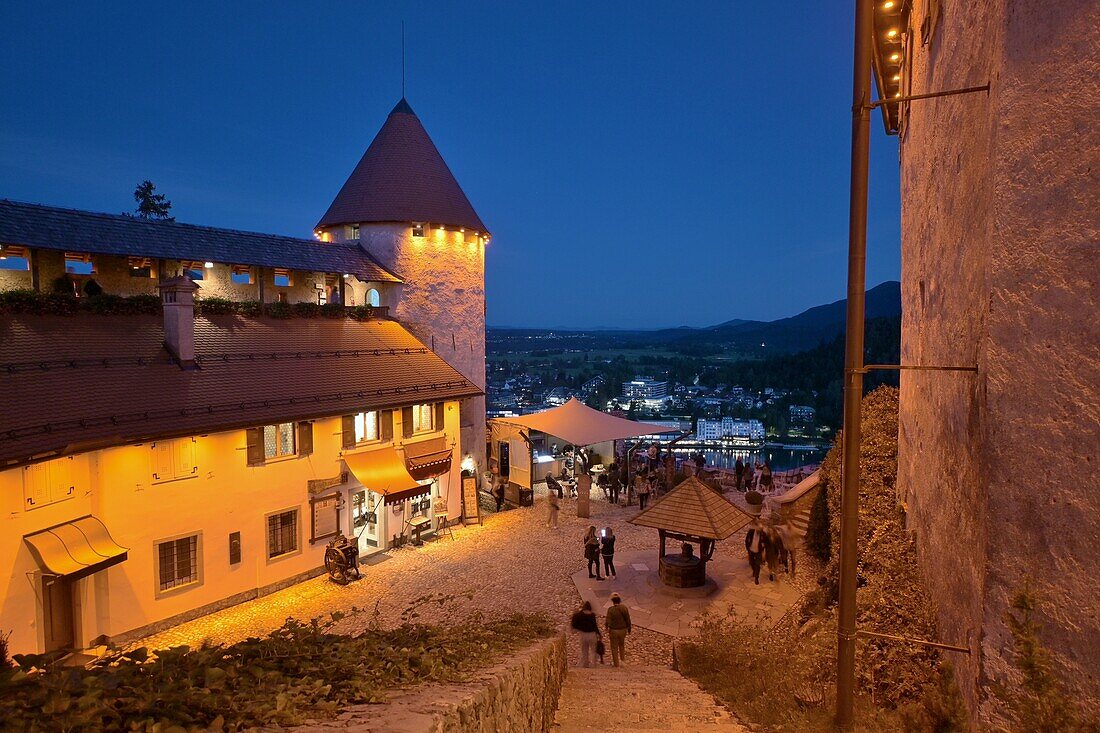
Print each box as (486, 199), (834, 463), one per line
(0, 314), (481, 464)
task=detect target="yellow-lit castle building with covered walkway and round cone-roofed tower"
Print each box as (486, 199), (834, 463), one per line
(0, 95), (487, 653)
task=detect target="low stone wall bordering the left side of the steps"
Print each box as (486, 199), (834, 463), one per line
(294, 636), (565, 733)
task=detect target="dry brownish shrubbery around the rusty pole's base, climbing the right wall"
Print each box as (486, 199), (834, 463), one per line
(682, 387), (967, 733)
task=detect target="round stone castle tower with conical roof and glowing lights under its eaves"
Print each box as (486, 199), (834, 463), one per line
(315, 98), (490, 472)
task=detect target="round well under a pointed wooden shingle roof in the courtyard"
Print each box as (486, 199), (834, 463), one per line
(630, 477), (751, 588)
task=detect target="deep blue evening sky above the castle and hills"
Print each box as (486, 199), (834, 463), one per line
(0, 0), (900, 327)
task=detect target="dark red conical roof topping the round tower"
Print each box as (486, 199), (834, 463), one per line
(317, 98), (486, 231)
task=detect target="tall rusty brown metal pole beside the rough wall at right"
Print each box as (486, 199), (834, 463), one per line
(836, 0), (875, 727)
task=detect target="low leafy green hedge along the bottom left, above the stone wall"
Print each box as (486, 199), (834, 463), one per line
(0, 613), (553, 731)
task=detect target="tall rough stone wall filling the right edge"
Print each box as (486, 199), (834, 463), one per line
(898, 0), (1100, 721)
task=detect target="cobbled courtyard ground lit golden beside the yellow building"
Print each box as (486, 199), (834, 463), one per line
(135, 491), (673, 666)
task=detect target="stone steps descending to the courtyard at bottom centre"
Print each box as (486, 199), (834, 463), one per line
(551, 666), (746, 733)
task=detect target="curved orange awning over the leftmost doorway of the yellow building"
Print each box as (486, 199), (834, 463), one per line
(23, 515), (128, 580)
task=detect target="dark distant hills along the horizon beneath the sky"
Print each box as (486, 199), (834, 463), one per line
(490, 281), (901, 353)
